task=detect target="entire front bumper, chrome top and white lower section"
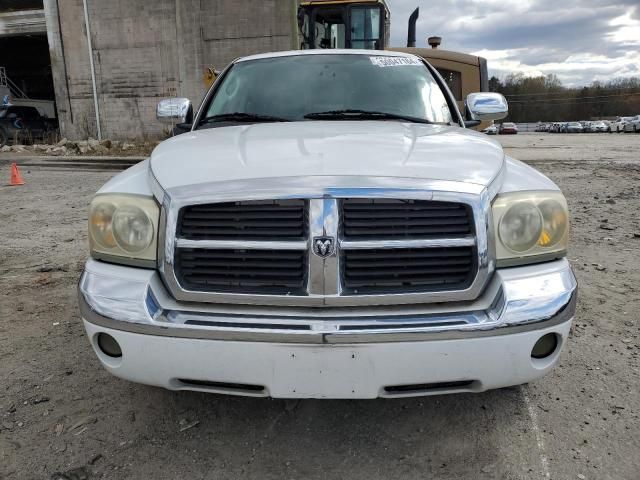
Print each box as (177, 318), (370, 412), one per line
(79, 260), (577, 398)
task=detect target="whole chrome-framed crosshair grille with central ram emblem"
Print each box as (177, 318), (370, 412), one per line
(160, 186), (484, 306)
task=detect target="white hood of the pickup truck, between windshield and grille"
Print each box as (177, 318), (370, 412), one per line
(150, 121), (505, 190)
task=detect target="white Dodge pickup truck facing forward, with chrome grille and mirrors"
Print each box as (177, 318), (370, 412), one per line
(79, 50), (577, 398)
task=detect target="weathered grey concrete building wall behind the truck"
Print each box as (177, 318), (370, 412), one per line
(44, 0), (296, 139)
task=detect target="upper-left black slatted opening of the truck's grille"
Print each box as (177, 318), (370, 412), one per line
(177, 199), (307, 240)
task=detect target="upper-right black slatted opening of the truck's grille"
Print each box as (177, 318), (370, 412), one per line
(342, 198), (473, 240)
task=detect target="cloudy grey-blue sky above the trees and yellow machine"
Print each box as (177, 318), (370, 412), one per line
(387, 0), (640, 86)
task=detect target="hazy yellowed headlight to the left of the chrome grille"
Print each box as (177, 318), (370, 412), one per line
(89, 194), (160, 267)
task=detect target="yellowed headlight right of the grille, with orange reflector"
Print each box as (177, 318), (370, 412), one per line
(493, 191), (569, 266)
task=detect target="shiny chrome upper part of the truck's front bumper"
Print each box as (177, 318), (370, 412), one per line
(78, 259), (577, 344)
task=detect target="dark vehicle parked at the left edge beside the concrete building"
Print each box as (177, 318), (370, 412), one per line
(0, 105), (58, 147)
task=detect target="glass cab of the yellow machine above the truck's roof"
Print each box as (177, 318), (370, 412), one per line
(298, 0), (389, 50)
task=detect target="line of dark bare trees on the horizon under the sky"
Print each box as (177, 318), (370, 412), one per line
(489, 73), (640, 122)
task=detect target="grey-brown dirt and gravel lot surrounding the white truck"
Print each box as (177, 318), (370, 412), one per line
(0, 134), (640, 480)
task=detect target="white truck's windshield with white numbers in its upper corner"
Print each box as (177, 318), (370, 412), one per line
(201, 54), (453, 126)
